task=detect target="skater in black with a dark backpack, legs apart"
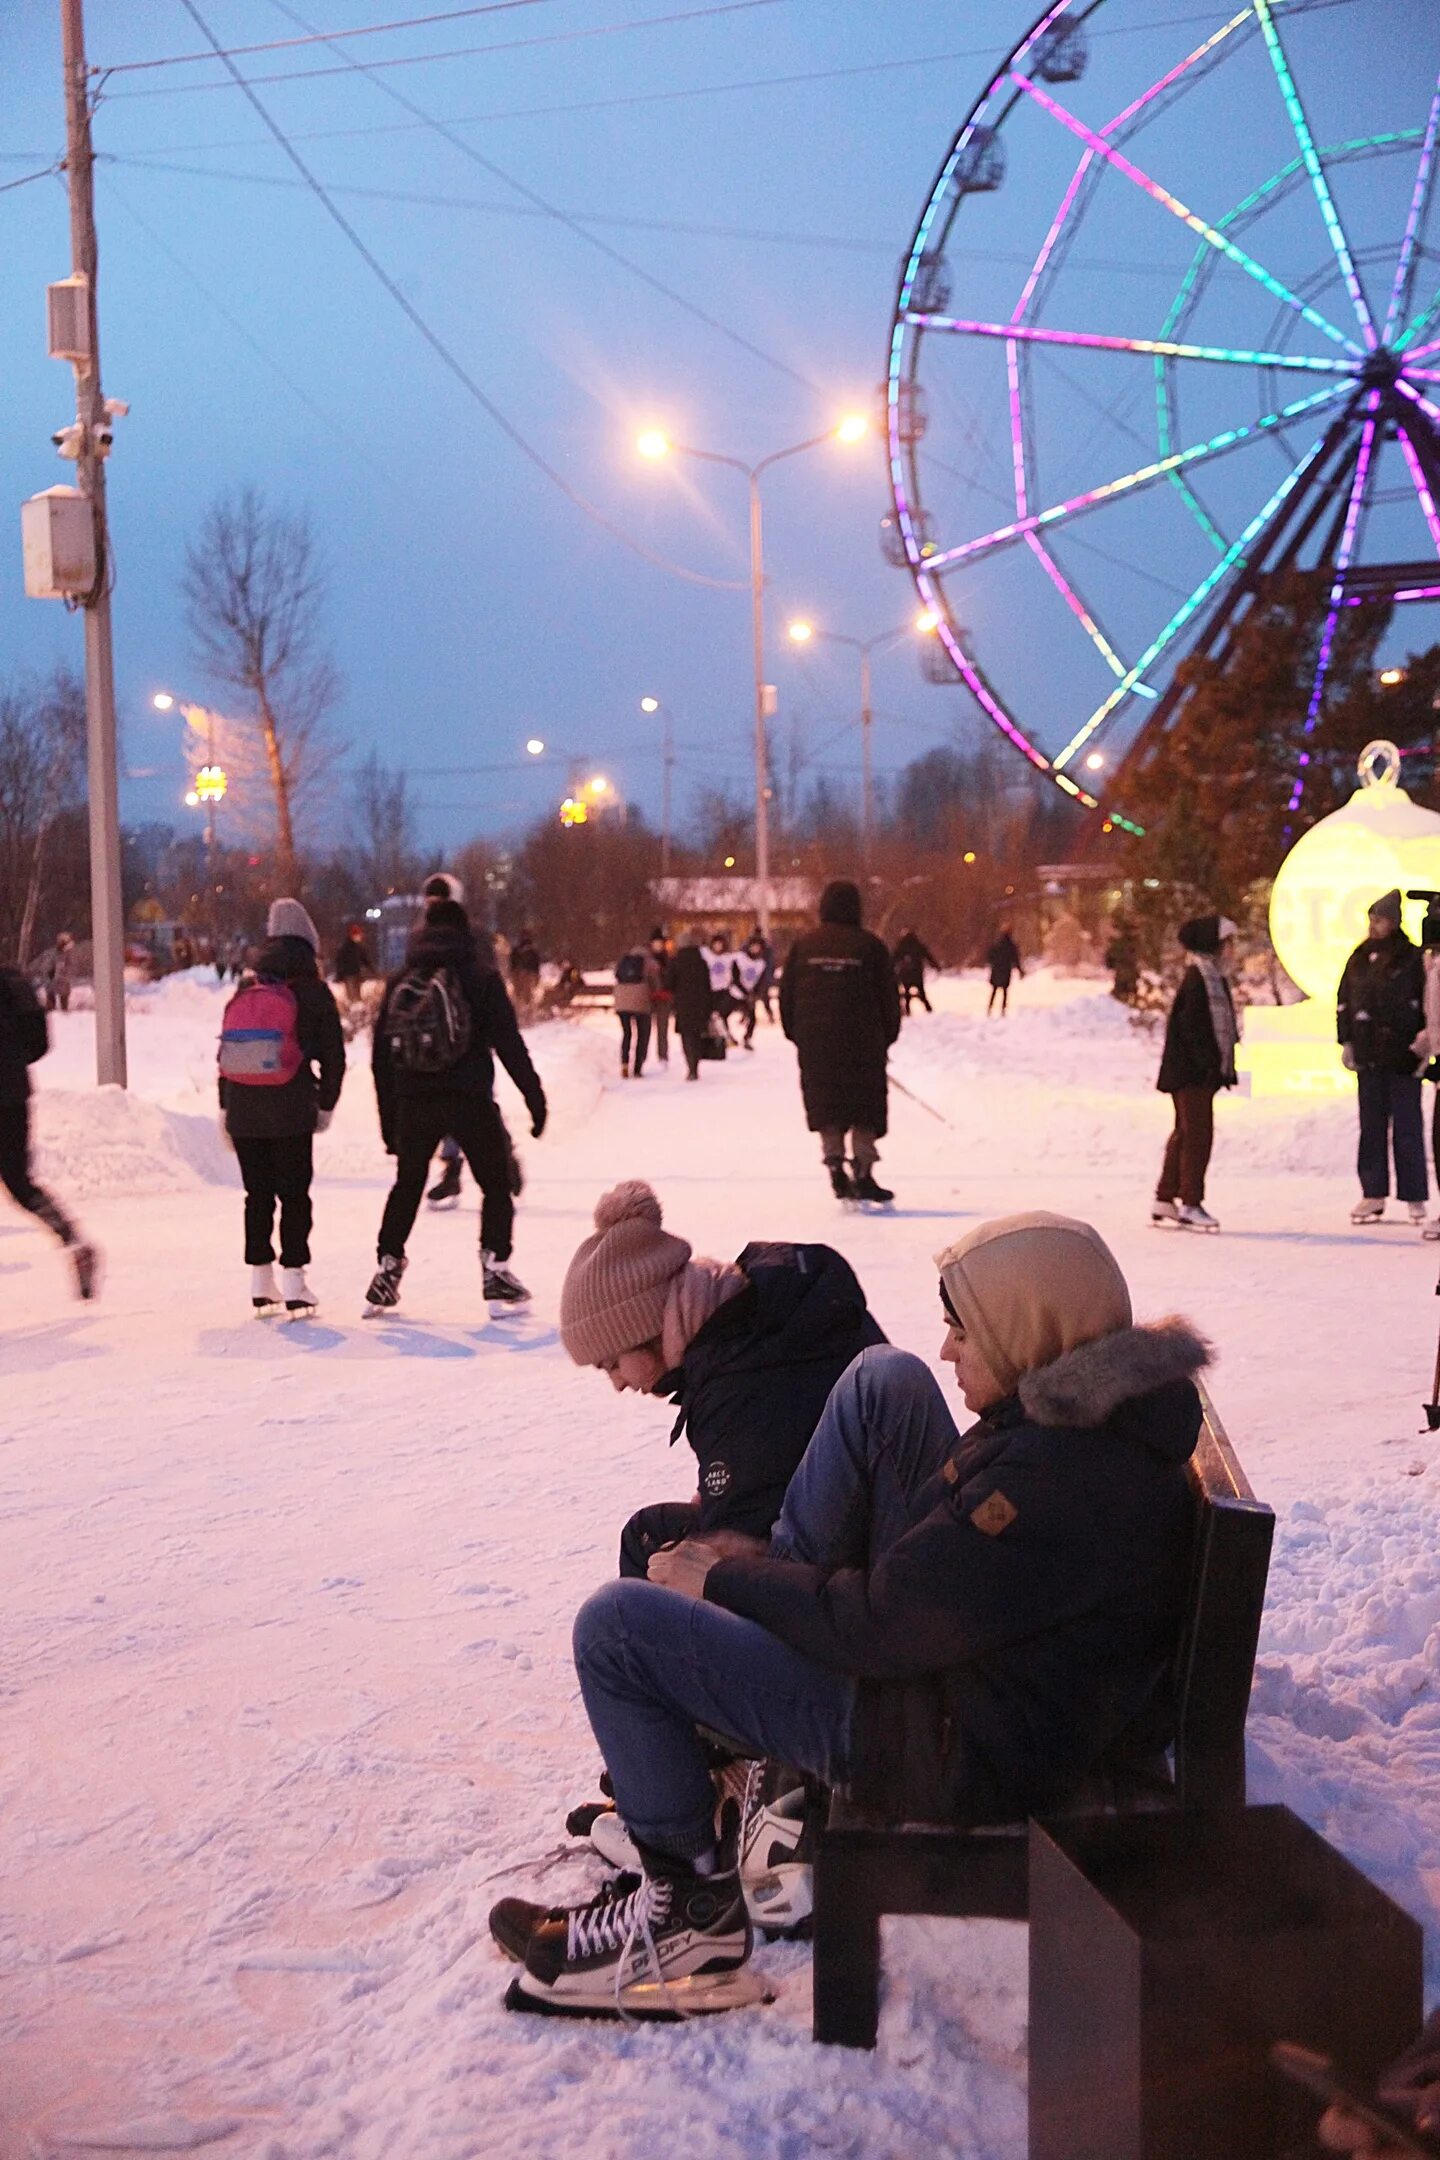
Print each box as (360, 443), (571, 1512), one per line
(365, 899), (546, 1313)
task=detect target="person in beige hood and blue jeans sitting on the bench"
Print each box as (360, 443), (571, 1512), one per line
(490, 1214), (1209, 2015)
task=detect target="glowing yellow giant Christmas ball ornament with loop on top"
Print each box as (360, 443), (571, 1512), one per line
(1237, 743), (1440, 1095)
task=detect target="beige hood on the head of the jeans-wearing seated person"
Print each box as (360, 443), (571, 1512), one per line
(937, 1212), (1131, 1395)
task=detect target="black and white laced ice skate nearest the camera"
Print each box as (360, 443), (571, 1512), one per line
(505, 1847), (764, 2020)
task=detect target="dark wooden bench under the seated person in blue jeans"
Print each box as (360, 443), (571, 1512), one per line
(814, 1393), (1276, 2048)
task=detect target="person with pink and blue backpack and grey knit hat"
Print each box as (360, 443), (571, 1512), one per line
(220, 901), (345, 1320)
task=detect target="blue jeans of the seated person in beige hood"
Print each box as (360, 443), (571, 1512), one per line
(574, 1344), (956, 1860)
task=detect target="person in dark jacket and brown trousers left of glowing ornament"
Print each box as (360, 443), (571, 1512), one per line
(1151, 916), (1239, 1229)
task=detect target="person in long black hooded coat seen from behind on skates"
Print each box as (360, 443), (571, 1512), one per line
(779, 879), (900, 1201)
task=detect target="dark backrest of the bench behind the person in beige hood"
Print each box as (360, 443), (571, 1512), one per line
(1174, 1389), (1276, 1808)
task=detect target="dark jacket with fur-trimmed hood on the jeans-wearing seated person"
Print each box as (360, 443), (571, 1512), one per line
(704, 1320), (1207, 1823)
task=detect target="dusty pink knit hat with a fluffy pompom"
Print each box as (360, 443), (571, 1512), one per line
(559, 1177), (691, 1365)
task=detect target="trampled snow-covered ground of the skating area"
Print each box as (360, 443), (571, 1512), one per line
(0, 976), (1440, 2160)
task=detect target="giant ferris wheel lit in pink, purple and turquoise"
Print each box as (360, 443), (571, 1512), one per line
(881, 0), (1440, 832)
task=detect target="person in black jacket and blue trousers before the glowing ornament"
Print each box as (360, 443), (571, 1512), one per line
(1334, 890), (1429, 1223)
